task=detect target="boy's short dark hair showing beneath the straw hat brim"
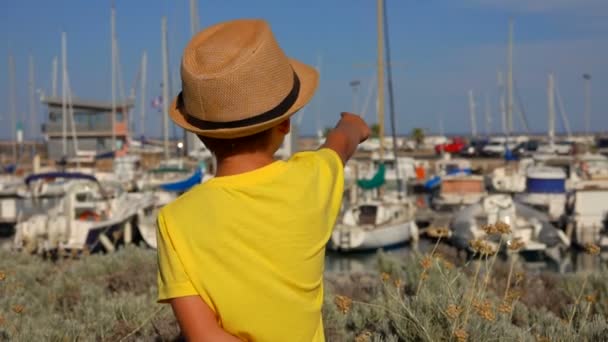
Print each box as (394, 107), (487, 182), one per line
(198, 128), (272, 157)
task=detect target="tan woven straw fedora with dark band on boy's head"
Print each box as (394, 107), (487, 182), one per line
(169, 20), (319, 139)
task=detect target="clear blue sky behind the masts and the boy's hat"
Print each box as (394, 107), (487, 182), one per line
(0, 0), (608, 139)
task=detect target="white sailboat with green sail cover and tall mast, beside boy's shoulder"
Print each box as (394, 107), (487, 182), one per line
(329, 0), (418, 251)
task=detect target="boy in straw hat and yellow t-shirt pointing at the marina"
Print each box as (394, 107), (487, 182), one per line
(158, 20), (369, 342)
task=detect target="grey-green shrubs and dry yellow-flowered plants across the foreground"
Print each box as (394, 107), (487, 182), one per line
(0, 227), (608, 342)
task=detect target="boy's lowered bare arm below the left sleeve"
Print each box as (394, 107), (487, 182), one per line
(170, 296), (241, 342)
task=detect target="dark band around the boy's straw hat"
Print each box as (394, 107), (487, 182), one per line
(177, 71), (300, 130)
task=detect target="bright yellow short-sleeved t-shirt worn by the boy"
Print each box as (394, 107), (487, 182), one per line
(157, 149), (344, 342)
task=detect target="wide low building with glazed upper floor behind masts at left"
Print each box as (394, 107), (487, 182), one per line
(42, 97), (133, 160)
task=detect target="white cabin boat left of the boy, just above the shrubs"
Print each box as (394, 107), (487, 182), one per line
(14, 173), (155, 254)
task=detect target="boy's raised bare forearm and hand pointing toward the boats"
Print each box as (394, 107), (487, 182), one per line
(321, 113), (370, 165)
